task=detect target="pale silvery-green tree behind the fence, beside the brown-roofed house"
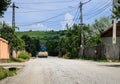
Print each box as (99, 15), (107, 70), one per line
(85, 17), (111, 46)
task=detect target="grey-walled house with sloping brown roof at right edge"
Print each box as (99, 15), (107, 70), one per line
(101, 23), (120, 60)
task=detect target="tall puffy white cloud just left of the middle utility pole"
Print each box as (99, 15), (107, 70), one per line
(61, 13), (74, 30)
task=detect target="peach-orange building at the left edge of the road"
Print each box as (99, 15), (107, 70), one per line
(0, 38), (10, 63)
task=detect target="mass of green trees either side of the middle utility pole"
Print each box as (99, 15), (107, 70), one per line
(58, 17), (110, 59)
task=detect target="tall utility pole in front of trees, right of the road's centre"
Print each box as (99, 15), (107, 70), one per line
(78, 0), (91, 57)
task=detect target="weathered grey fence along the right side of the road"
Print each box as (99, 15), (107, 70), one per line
(84, 45), (120, 60)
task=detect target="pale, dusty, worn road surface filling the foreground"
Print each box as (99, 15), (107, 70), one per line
(0, 57), (120, 84)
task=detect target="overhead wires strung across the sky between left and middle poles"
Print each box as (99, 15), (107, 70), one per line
(8, 0), (79, 26)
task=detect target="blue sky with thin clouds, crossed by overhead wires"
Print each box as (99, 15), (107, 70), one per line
(0, 0), (112, 31)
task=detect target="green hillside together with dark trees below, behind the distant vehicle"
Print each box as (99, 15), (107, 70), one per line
(17, 31), (66, 56)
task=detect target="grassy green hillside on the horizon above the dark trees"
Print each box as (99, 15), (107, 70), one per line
(17, 31), (65, 44)
